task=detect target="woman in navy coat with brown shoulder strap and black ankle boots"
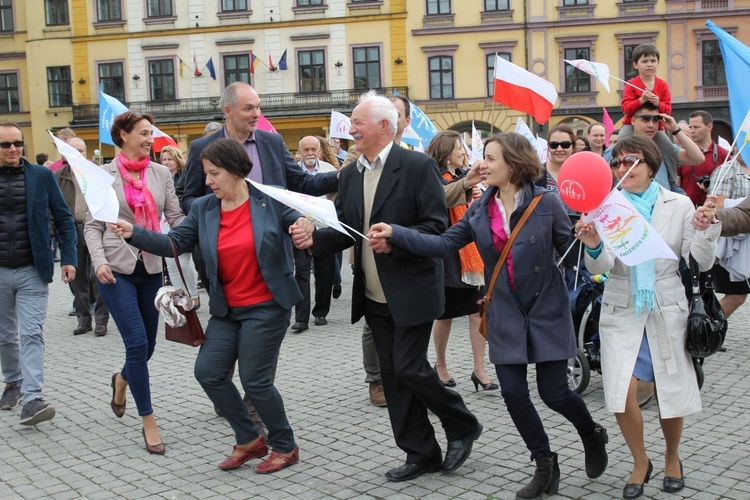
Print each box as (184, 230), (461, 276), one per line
(368, 133), (607, 499)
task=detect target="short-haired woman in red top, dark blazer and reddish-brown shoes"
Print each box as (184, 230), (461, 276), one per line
(110, 139), (314, 474)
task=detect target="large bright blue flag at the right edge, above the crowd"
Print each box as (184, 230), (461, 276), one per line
(706, 21), (750, 163)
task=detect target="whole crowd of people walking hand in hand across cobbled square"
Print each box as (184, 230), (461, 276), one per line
(0, 44), (750, 499)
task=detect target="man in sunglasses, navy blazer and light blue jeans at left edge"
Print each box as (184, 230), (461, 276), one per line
(0, 123), (78, 425)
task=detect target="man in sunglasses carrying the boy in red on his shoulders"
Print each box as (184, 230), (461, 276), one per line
(604, 101), (703, 194)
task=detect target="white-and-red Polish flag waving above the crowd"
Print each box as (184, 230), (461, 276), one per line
(493, 56), (557, 124)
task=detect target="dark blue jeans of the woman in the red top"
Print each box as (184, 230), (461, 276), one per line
(195, 301), (297, 453)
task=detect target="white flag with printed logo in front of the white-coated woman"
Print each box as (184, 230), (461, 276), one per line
(585, 190), (677, 266)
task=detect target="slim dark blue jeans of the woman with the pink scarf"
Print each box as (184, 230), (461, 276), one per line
(99, 261), (162, 416)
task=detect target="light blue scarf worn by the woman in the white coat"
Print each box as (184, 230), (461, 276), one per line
(622, 181), (659, 316)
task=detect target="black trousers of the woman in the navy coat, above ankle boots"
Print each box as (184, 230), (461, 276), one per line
(495, 360), (594, 460)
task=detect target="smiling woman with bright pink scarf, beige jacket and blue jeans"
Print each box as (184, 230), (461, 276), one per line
(84, 111), (184, 455)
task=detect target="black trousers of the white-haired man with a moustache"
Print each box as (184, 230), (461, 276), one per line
(365, 300), (478, 464)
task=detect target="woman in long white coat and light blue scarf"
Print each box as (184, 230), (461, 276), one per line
(576, 135), (721, 498)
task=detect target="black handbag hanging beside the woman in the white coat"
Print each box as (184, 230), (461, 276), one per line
(686, 255), (727, 358)
